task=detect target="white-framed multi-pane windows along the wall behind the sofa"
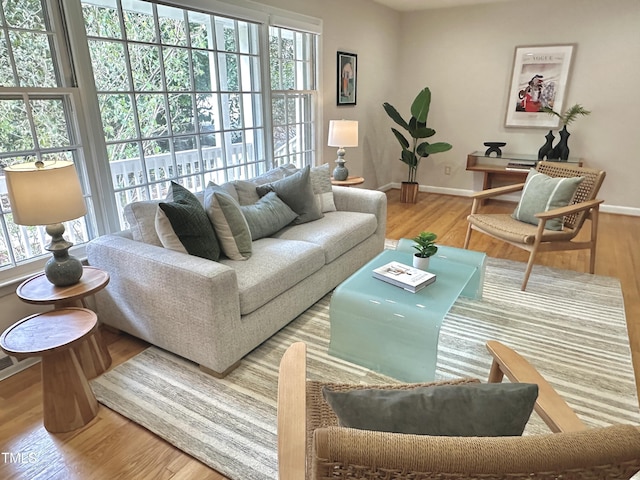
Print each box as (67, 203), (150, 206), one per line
(0, 0), (317, 283)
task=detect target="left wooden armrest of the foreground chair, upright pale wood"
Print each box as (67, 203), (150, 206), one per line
(278, 342), (307, 480)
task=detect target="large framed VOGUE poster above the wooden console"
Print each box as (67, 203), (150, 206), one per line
(505, 44), (576, 128)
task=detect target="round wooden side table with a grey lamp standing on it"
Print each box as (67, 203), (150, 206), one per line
(16, 266), (111, 379)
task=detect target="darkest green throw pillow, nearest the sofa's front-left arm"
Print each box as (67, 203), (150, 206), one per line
(159, 182), (220, 261)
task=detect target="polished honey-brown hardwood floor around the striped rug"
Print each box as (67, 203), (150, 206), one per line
(0, 190), (640, 480)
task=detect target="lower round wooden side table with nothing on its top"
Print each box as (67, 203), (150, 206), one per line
(0, 307), (98, 433)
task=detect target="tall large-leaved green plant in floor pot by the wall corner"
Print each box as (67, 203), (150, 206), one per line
(382, 87), (452, 203)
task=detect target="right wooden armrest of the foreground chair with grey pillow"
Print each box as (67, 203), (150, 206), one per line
(487, 340), (586, 433)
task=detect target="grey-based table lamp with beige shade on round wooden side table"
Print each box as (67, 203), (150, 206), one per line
(4, 161), (87, 287)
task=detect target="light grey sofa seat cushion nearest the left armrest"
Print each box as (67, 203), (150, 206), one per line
(220, 238), (324, 315)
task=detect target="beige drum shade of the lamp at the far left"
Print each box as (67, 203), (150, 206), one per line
(4, 161), (87, 225)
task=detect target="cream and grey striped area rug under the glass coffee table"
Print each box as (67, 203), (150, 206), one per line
(91, 259), (640, 480)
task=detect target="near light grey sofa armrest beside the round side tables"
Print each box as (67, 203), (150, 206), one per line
(87, 235), (242, 372)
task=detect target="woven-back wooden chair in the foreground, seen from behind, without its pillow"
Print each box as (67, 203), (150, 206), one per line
(278, 341), (640, 480)
